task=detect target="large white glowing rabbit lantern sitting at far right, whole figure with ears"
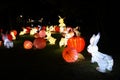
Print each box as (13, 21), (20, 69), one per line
(87, 33), (114, 73)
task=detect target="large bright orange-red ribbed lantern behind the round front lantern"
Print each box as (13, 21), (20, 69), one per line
(67, 36), (85, 52)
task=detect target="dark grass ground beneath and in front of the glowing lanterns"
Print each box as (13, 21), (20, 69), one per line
(0, 34), (120, 80)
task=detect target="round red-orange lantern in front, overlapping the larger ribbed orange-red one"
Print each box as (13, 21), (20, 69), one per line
(62, 47), (78, 63)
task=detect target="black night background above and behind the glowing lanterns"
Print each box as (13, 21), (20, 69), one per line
(0, 0), (120, 79)
